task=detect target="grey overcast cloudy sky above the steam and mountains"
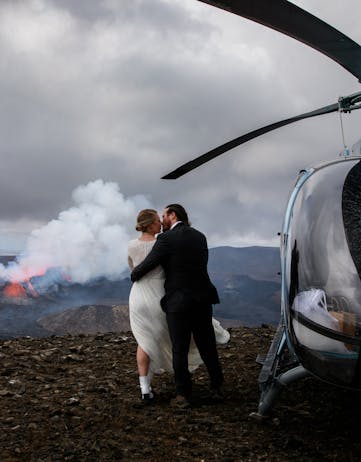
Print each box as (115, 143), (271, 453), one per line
(0, 0), (361, 253)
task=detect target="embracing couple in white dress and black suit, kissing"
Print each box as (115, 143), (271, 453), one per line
(128, 204), (229, 407)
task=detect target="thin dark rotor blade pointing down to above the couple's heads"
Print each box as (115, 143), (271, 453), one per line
(162, 103), (339, 180)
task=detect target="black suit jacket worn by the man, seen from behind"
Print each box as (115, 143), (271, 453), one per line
(131, 223), (219, 312)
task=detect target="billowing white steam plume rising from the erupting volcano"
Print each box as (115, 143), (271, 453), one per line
(0, 180), (150, 283)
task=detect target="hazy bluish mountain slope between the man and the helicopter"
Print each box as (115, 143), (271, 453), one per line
(208, 247), (281, 326)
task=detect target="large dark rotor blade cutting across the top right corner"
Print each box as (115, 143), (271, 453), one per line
(199, 0), (361, 81)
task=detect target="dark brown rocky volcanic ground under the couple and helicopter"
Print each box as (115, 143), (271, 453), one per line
(0, 327), (361, 462)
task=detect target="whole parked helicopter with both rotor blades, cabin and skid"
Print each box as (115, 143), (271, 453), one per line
(162, 0), (361, 418)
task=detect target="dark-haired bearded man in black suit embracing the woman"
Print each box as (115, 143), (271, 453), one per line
(131, 204), (223, 407)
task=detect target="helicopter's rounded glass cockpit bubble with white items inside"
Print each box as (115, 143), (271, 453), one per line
(282, 157), (361, 388)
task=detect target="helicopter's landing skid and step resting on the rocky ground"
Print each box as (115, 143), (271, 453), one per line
(250, 319), (309, 419)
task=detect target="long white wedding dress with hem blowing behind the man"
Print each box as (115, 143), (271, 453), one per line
(128, 239), (230, 373)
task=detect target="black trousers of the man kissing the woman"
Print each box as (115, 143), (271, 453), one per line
(166, 305), (223, 397)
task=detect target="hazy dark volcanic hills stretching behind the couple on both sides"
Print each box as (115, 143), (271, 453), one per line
(0, 247), (281, 338)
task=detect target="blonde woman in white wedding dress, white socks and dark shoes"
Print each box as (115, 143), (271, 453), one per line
(128, 209), (230, 403)
